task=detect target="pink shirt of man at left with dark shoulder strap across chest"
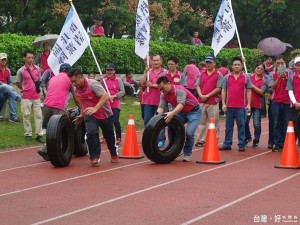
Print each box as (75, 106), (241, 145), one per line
(17, 64), (41, 100)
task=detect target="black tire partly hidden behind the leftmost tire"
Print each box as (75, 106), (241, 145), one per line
(73, 121), (88, 157)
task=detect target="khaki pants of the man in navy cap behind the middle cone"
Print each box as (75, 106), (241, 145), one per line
(197, 103), (219, 142)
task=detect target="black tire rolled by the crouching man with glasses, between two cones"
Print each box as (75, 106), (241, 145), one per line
(142, 114), (185, 164)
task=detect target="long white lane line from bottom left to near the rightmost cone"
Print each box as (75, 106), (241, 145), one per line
(33, 151), (270, 225)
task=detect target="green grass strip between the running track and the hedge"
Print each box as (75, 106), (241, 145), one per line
(0, 96), (144, 151)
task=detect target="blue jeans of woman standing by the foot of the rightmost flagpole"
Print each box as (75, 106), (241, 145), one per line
(245, 108), (261, 143)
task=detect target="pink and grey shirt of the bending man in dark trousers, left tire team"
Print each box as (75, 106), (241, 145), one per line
(75, 79), (113, 119)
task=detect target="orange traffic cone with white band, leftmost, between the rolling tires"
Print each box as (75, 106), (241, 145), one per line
(120, 115), (144, 159)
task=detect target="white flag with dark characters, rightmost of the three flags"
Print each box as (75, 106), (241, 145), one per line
(211, 0), (235, 56)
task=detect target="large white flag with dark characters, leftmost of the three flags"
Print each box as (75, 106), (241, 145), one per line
(47, 4), (90, 75)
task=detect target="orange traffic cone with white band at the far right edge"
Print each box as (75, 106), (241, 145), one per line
(275, 121), (300, 169)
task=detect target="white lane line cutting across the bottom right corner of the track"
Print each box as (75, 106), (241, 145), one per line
(182, 172), (300, 225)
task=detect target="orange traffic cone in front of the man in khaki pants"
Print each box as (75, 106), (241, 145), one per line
(196, 118), (226, 164)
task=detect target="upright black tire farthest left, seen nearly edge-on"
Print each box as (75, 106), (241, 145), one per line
(46, 115), (74, 167)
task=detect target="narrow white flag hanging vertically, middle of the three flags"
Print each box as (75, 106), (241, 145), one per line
(135, 0), (150, 59)
